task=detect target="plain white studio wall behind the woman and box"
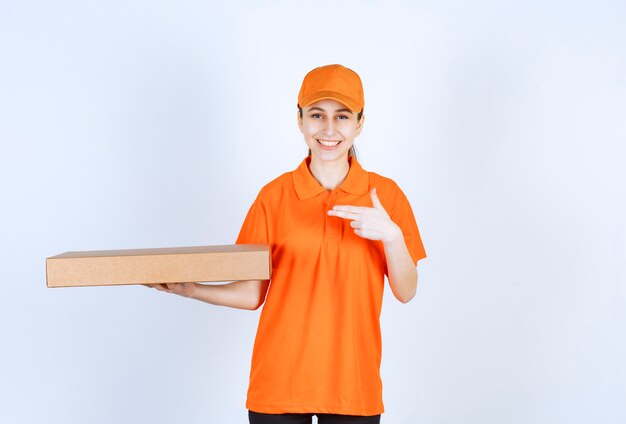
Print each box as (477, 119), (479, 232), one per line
(0, 0), (626, 424)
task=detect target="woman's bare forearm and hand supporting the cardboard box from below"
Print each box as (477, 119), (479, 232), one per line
(145, 280), (269, 310)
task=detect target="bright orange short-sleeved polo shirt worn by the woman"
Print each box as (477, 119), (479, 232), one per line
(236, 157), (426, 415)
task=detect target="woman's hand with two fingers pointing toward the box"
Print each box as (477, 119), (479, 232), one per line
(328, 188), (402, 243)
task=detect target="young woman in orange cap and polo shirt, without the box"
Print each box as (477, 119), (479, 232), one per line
(146, 65), (426, 424)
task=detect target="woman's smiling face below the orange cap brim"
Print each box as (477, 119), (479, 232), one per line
(298, 99), (364, 161)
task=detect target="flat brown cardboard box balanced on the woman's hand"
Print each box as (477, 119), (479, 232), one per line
(46, 244), (271, 287)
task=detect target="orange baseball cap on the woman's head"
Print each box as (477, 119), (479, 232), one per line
(298, 64), (365, 112)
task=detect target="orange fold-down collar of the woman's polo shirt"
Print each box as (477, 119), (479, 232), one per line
(291, 156), (369, 200)
